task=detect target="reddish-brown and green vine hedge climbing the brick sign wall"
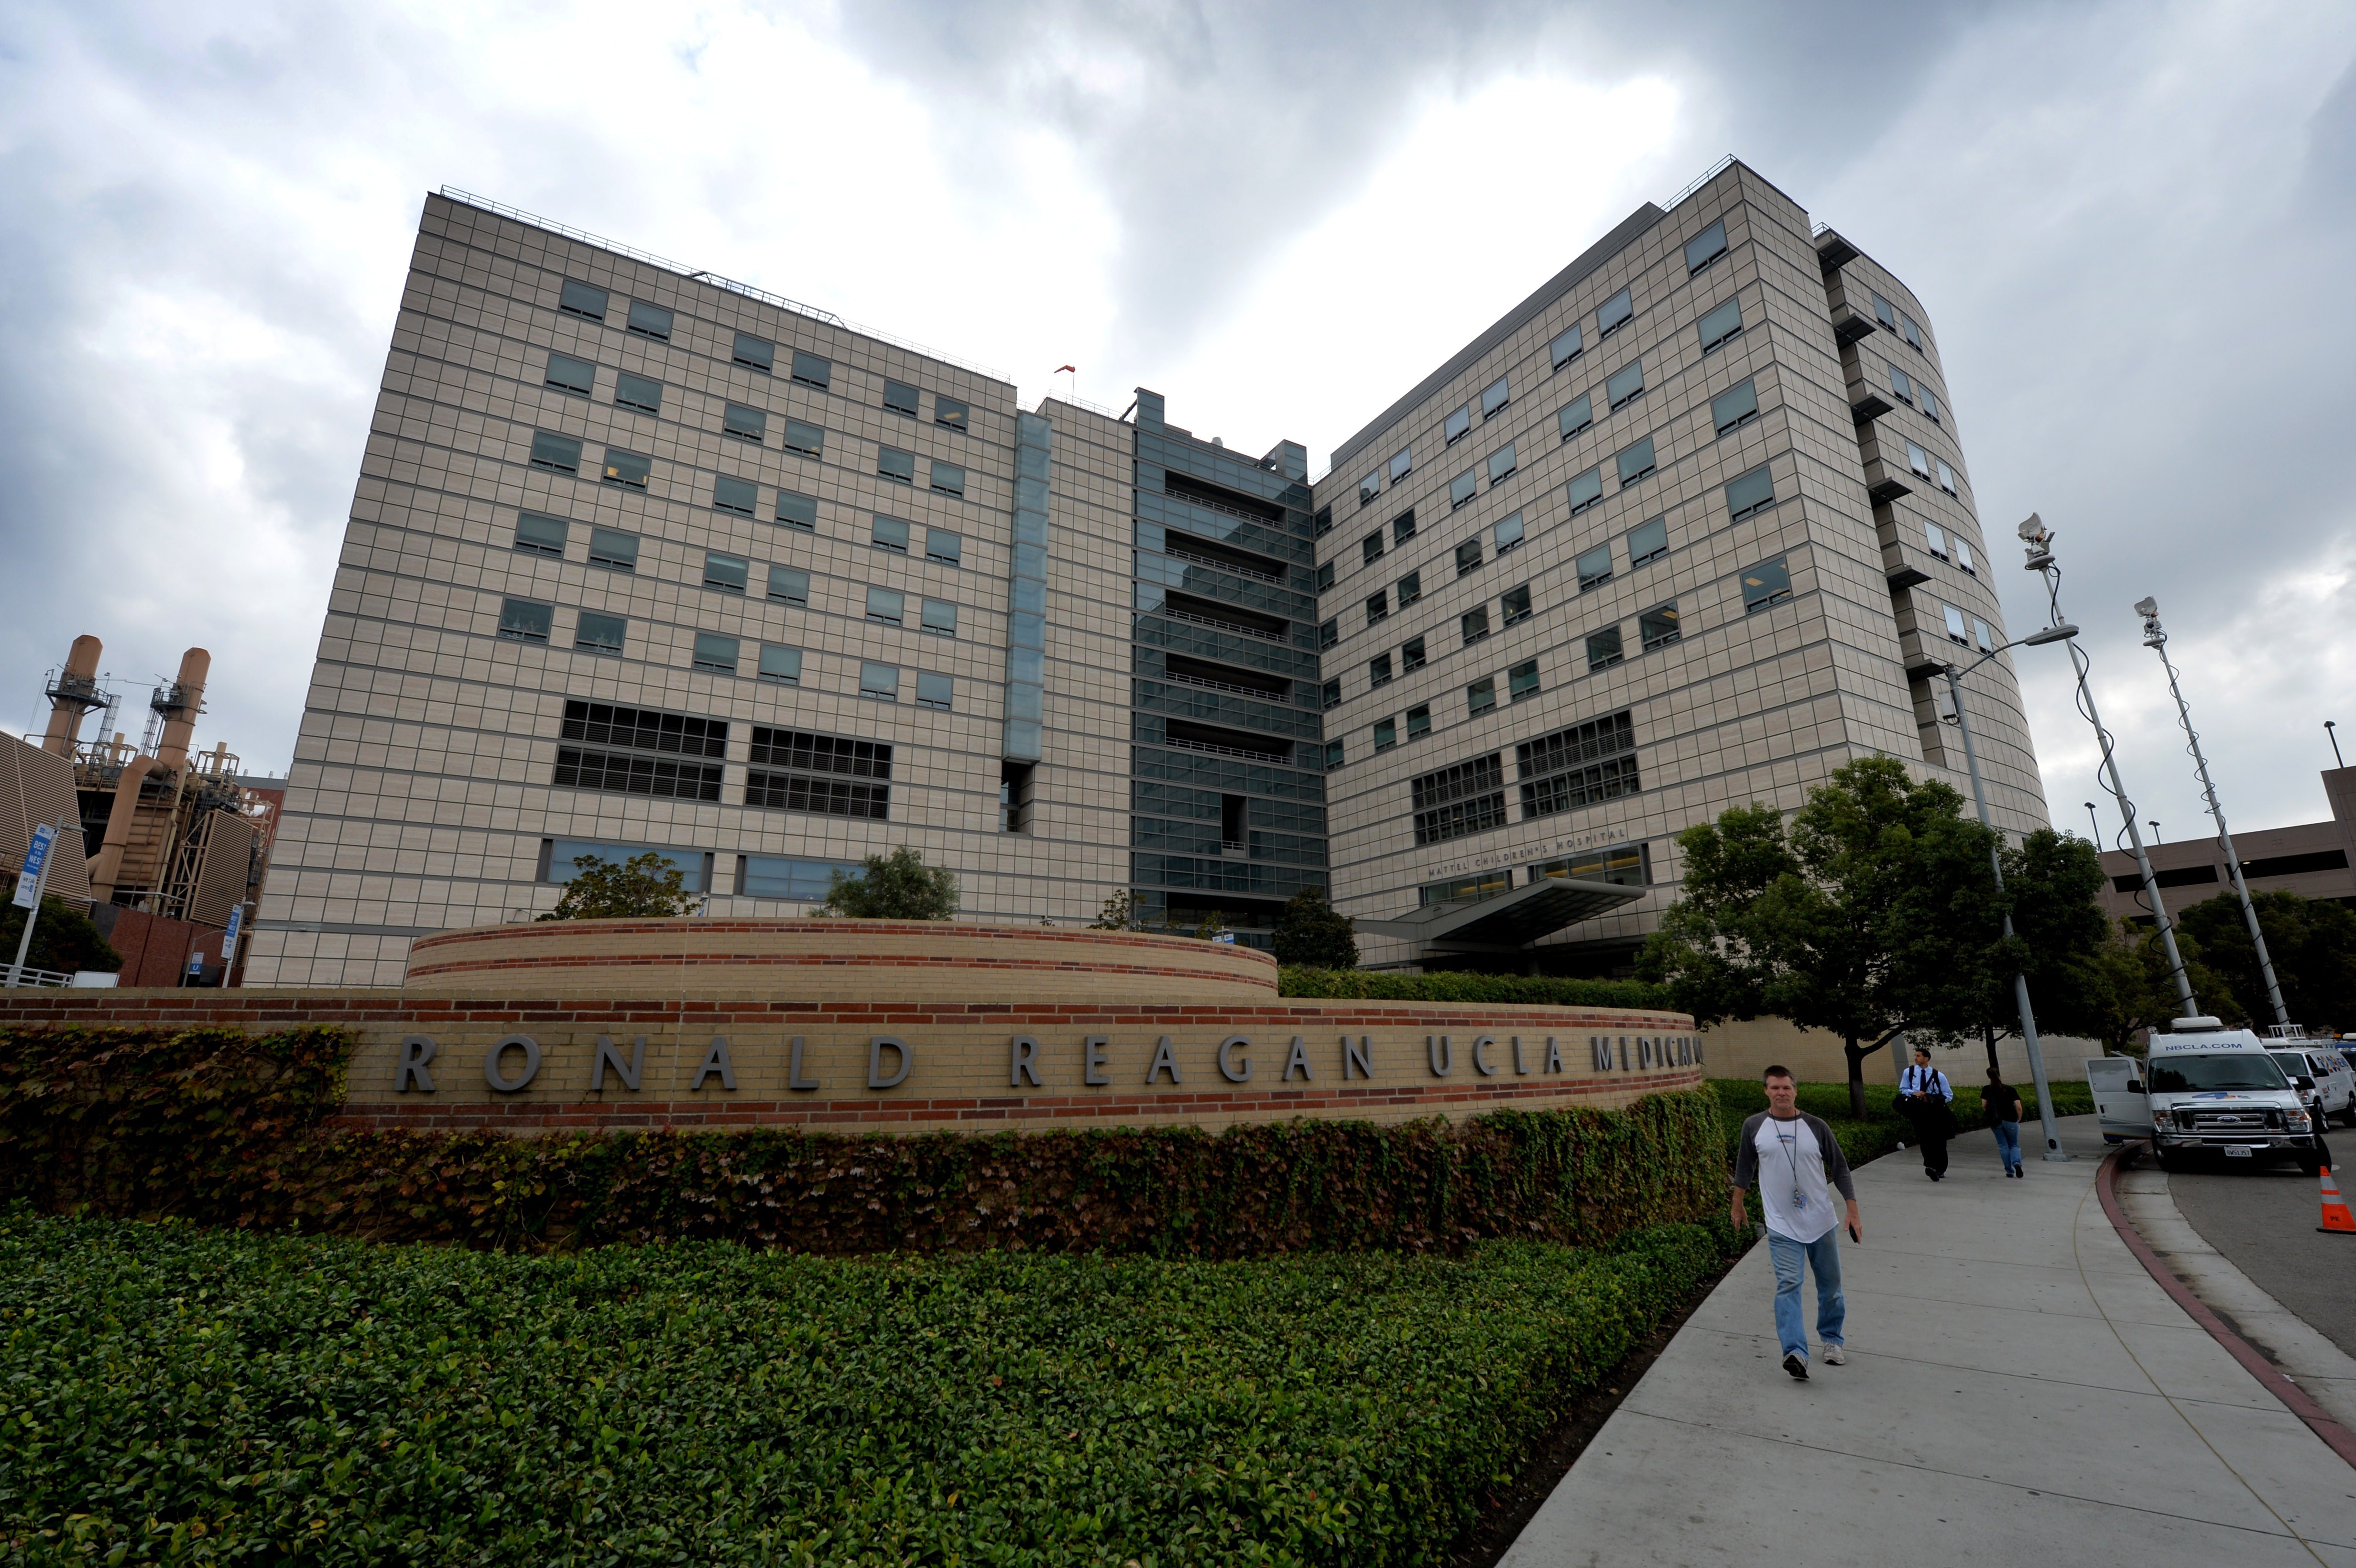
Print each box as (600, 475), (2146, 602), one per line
(0, 1029), (1724, 1257)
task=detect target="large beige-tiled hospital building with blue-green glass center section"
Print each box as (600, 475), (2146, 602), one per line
(234, 160), (2045, 984)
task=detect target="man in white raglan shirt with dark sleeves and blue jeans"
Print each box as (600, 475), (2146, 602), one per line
(1734, 1067), (1866, 1380)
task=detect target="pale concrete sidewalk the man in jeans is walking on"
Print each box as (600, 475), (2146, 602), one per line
(1503, 1116), (2356, 1568)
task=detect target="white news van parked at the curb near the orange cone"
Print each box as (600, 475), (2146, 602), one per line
(2085, 1017), (2323, 1175)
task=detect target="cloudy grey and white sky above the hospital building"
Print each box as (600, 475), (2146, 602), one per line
(0, 0), (2356, 838)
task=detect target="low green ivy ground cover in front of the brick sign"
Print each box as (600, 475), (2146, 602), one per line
(0, 1203), (1734, 1568)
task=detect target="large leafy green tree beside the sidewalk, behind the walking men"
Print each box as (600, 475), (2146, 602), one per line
(1640, 756), (2026, 1116)
